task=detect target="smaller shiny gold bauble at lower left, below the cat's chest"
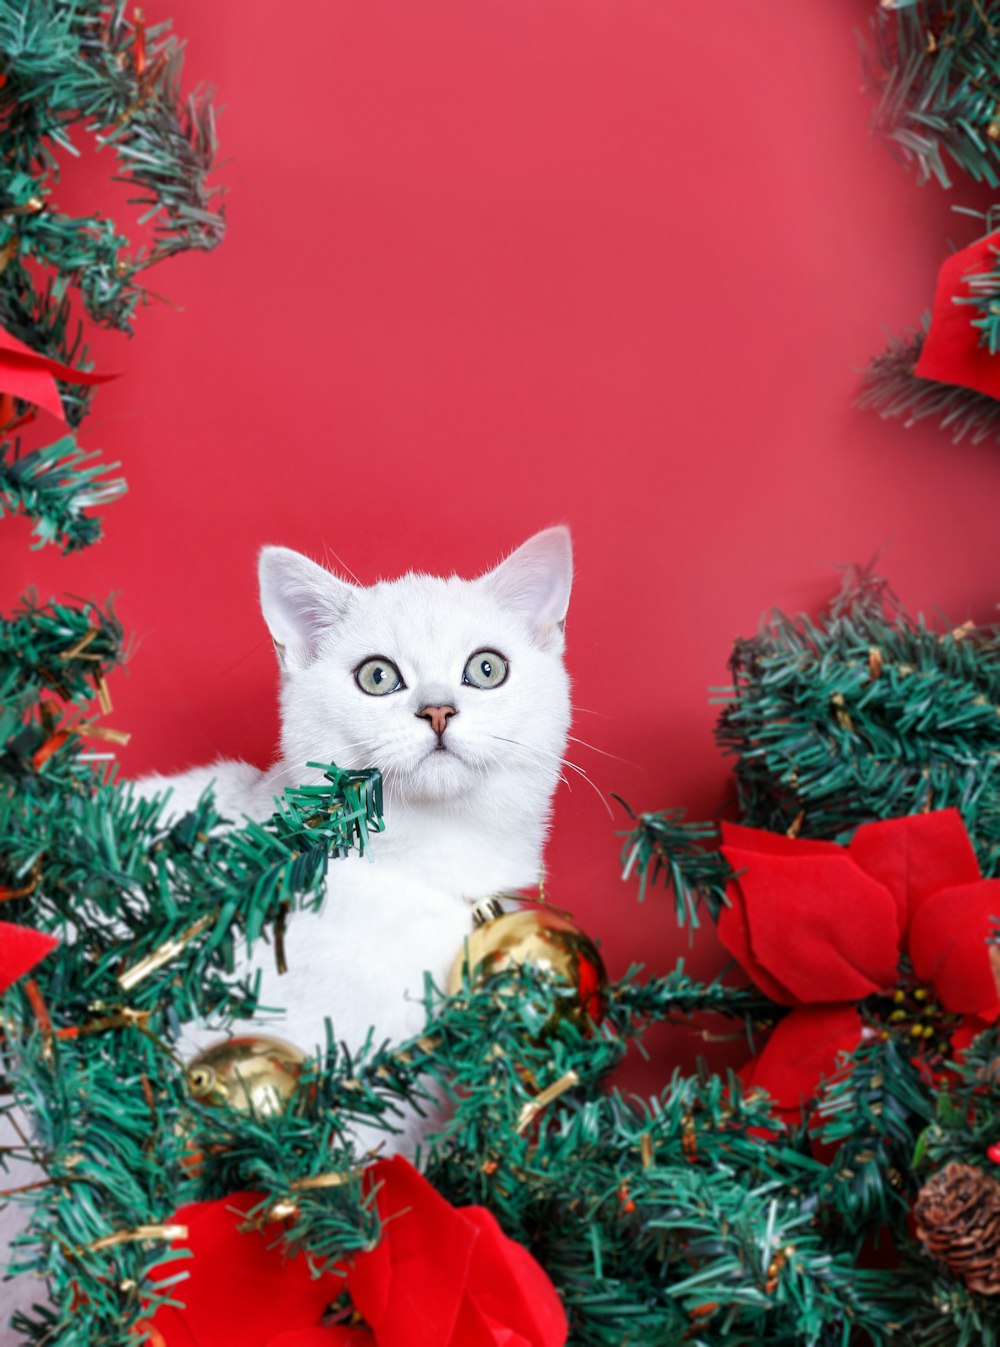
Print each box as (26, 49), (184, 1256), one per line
(186, 1034), (306, 1118)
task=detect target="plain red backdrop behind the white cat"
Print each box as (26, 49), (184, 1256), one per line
(0, 0), (1000, 1078)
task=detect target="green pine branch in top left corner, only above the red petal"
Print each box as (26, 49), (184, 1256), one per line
(0, 0), (224, 309)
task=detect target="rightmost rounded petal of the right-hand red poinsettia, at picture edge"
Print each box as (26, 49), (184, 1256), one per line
(910, 880), (1000, 1014)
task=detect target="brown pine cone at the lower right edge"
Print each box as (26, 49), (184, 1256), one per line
(914, 1164), (1000, 1296)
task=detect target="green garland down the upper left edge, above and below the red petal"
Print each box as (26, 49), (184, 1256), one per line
(0, 0), (225, 530)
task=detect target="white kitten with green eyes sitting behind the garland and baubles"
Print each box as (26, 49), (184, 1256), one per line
(137, 528), (573, 1082)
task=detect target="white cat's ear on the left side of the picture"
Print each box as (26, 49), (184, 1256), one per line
(257, 547), (354, 672)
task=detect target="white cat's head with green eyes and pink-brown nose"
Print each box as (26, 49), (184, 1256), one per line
(260, 528), (573, 808)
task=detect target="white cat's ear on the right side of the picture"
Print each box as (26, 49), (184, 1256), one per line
(482, 524), (573, 649)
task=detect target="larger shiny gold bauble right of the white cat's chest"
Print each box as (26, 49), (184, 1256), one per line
(447, 900), (608, 1032)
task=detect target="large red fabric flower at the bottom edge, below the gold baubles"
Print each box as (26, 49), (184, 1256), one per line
(147, 1156), (567, 1347)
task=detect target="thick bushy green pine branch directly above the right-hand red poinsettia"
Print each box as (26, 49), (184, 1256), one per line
(716, 557), (1000, 876)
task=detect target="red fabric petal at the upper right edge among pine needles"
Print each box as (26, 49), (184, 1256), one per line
(915, 233), (1000, 397)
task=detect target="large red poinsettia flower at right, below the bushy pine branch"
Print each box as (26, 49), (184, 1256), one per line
(718, 810), (1000, 1121)
